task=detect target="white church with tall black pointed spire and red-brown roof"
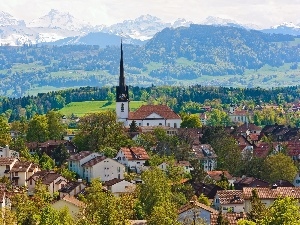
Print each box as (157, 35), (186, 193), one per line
(116, 42), (181, 128)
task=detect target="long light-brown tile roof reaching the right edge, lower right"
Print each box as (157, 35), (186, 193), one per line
(243, 187), (300, 199)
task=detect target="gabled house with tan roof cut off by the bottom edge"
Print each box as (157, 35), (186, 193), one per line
(178, 198), (218, 224)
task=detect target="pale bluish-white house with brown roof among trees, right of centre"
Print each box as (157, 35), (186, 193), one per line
(193, 144), (217, 171)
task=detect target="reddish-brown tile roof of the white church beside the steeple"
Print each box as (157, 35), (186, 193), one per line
(128, 105), (180, 120)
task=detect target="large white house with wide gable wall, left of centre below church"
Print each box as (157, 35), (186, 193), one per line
(79, 156), (125, 182)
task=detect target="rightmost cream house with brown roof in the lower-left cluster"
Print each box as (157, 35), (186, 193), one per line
(27, 170), (68, 195)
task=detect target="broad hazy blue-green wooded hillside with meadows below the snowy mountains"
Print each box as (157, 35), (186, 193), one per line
(0, 25), (300, 97)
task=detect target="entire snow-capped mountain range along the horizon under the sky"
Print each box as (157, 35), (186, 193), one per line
(0, 9), (300, 47)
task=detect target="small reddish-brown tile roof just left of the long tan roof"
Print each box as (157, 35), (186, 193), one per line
(217, 190), (244, 205)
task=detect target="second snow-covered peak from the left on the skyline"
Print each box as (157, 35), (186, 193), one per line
(28, 9), (92, 31)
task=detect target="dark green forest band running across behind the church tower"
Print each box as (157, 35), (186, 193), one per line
(0, 85), (300, 121)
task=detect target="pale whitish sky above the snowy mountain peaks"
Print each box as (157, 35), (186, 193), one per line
(0, 0), (300, 27)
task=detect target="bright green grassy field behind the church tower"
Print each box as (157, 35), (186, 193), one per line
(59, 101), (146, 117)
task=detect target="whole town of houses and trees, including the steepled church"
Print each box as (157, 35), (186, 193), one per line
(0, 43), (300, 225)
